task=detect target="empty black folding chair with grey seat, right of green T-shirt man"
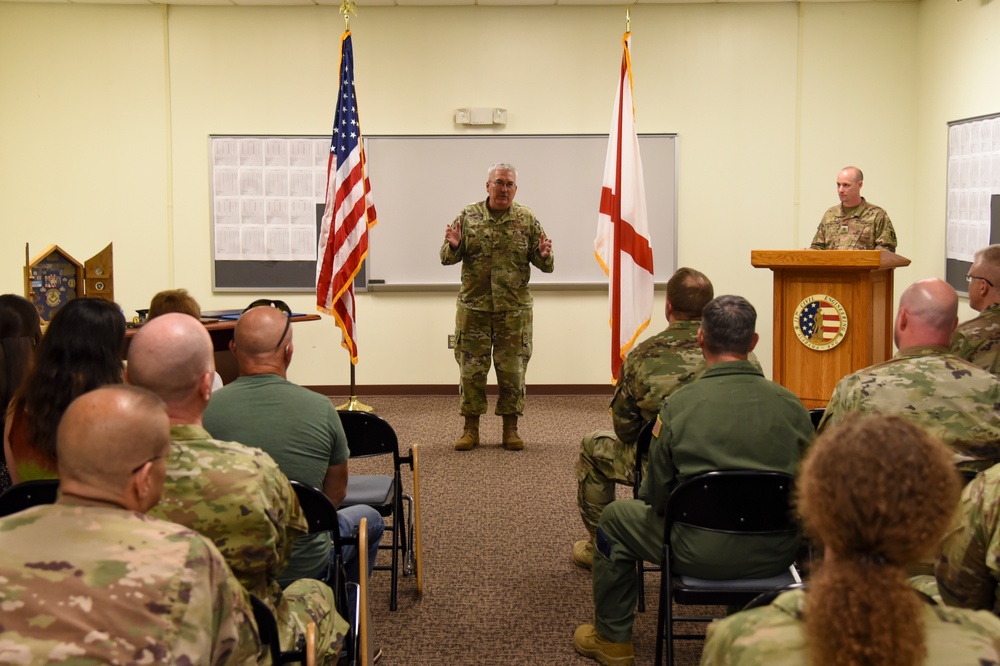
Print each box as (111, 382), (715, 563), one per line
(339, 410), (423, 611)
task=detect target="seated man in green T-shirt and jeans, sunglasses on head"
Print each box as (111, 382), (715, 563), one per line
(205, 306), (384, 585)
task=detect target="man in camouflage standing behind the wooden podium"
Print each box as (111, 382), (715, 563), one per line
(810, 167), (896, 252)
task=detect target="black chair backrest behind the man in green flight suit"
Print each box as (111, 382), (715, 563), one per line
(667, 470), (799, 534)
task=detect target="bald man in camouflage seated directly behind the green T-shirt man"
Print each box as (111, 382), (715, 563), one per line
(126, 313), (347, 663)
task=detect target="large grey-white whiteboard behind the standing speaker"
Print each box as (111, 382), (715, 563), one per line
(365, 134), (677, 290)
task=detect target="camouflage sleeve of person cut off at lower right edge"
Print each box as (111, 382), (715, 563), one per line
(934, 472), (1000, 611)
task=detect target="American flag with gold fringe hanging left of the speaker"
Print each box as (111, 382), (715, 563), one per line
(316, 30), (376, 363)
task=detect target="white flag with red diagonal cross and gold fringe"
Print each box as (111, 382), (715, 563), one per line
(594, 32), (653, 380)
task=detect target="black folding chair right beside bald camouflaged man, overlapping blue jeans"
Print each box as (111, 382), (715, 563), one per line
(291, 481), (368, 664)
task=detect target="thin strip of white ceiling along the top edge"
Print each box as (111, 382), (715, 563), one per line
(0, 0), (912, 7)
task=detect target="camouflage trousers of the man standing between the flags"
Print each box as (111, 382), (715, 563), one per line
(455, 307), (531, 416)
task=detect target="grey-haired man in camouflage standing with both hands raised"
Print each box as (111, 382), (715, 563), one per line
(441, 162), (555, 451)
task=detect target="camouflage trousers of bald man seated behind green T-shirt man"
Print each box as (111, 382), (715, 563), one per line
(274, 578), (348, 665)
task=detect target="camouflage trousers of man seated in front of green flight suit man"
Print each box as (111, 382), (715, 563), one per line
(576, 430), (648, 541)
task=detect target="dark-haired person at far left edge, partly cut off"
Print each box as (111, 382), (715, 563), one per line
(0, 294), (42, 492)
